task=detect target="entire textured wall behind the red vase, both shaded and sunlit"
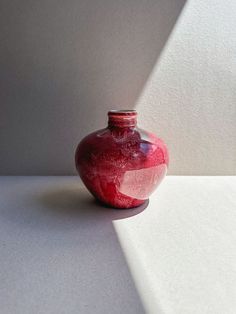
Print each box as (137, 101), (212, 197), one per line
(0, 0), (236, 175)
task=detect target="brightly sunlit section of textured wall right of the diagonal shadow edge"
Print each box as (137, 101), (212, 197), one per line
(136, 0), (236, 175)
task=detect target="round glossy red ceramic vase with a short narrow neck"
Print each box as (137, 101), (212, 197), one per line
(75, 110), (169, 208)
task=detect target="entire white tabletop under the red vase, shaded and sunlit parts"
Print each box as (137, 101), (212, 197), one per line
(0, 176), (236, 314)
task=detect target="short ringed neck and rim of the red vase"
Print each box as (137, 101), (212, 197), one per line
(108, 110), (137, 128)
